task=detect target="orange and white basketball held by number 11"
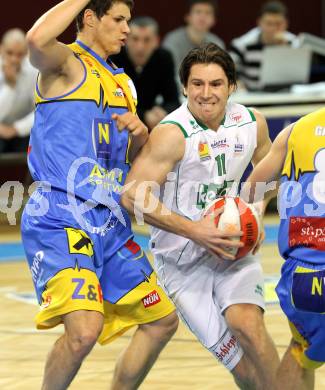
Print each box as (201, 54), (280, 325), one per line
(204, 197), (261, 260)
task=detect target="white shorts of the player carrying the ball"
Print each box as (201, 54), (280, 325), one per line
(152, 241), (265, 371)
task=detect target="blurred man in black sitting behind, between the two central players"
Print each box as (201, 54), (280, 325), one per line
(111, 16), (179, 129)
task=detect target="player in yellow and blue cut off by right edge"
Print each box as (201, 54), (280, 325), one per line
(248, 108), (325, 390)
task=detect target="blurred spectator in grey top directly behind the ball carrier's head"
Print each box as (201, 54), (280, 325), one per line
(162, 0), (225, 79)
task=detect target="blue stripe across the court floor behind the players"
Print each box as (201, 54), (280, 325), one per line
(0, 225), (278, 263)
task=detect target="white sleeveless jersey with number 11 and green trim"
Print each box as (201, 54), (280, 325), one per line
(151, 102), (257, 254)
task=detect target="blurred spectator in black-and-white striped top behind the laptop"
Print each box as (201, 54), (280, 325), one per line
(230, 1), (296, 91)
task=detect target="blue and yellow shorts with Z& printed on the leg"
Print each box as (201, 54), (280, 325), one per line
(21, 191), (174, 344)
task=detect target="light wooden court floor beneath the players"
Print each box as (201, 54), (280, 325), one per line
(0, 219), (325, 390)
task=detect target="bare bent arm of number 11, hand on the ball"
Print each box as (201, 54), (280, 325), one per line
(121, 125), (242, 259)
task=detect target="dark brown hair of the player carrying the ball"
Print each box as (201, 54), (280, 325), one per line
(179, 43), (237, 88)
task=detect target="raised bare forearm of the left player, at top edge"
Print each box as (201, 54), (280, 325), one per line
(27, 0), (90, 48)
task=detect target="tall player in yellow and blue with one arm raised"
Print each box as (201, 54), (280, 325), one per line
(22, 0), (177, 390)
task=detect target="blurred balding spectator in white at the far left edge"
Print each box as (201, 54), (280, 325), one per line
(0, 28), (37, 153)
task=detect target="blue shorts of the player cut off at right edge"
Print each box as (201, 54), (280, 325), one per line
(276, 258), (325, 369)
